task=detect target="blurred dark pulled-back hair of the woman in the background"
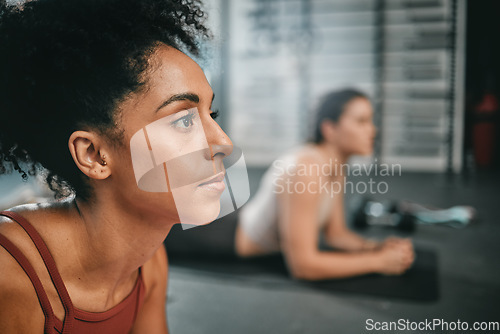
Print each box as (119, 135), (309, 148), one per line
(310, 88), (368, 144)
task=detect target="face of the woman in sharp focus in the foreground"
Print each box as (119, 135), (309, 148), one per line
(107, 46), (232, 225)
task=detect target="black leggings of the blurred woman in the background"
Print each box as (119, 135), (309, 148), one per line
(165, 211), (238, 258)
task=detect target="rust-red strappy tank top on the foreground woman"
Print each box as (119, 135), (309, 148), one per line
(0, 211), (144, 334)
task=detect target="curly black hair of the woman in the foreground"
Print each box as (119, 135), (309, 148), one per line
(0, 0), (210, 199)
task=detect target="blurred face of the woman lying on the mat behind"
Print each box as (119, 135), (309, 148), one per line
(335, 98), (376, 156)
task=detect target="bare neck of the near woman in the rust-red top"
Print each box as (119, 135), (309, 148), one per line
(70, 196), (174, 291)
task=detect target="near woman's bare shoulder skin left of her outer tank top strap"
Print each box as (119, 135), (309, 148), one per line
(0, 234), (45, 334)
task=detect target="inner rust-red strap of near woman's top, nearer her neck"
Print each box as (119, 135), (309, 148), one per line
(0, 211), (75, 334)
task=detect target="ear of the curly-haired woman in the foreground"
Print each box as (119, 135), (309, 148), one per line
(68, 131), (111, 180)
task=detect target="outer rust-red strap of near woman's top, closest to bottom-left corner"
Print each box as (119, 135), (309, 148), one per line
(0, 234), (55, 334)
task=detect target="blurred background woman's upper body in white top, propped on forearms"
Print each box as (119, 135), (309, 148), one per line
(235, 89), (414, 280)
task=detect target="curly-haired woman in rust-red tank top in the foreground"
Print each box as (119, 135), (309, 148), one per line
(0, 0), (231, 334)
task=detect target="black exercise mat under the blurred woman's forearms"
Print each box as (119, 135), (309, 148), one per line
(169, 249), (439, 302)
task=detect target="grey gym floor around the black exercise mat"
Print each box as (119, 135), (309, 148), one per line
(167, 170), (500, 334)
